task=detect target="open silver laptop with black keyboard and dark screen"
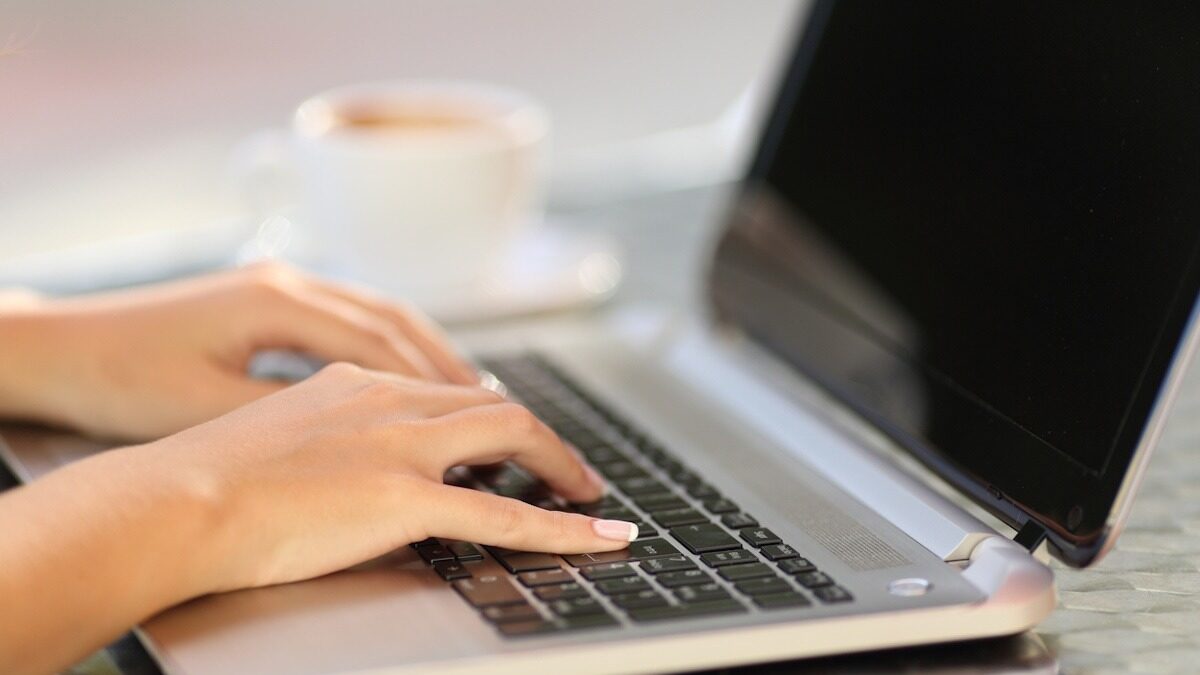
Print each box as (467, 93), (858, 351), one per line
(5, 0), (1200, 675)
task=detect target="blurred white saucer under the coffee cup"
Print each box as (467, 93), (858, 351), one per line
(294, 225), (622, 323)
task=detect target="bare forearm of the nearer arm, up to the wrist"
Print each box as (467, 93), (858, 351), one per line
(0, 447), (214, 673)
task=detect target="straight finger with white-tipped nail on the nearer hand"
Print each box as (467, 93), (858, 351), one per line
(412, 485), (637, 554)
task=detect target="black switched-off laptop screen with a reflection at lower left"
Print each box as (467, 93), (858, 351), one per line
(714, 1), (1200, 564)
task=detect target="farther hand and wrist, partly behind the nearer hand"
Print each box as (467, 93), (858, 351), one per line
(0, 264), (475, 440)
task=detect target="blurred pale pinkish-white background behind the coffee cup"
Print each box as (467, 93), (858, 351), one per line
(0, 0), (803, 291)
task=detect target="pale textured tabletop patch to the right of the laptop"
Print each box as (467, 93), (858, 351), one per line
(1038, 381), (1200, 673)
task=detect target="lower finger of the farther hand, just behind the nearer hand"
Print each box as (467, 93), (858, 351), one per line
(260, 282), (444, 381)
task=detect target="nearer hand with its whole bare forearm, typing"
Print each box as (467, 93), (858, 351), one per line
(0, 364), (637, 671)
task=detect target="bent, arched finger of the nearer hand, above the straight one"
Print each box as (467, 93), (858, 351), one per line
(412, 402), (604, 502)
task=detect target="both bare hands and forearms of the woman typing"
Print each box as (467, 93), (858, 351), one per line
(0, 267), (636, 673)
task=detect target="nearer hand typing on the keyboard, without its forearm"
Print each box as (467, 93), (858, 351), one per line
(152, 364), (636, 592)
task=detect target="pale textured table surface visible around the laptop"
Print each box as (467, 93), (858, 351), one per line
(7, 183), (1200, 674)
